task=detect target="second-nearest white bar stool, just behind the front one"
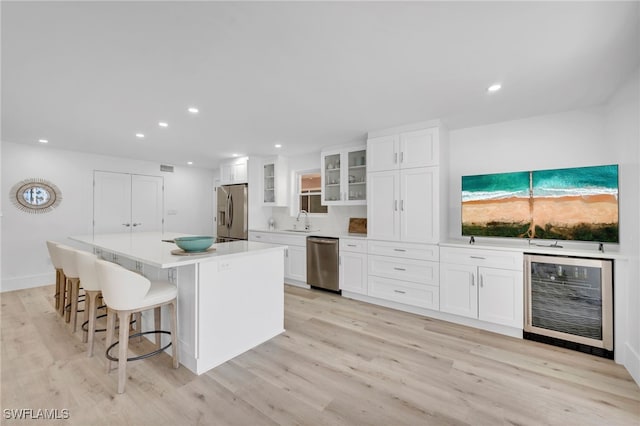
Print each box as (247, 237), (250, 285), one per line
(75, 250), (105, 356)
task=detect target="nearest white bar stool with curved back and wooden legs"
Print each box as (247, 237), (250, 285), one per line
(95, 259), (178, 393)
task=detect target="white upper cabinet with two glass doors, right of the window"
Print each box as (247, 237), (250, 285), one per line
(320, 146), (367, 206)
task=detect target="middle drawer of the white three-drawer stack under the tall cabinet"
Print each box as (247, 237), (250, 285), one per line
(368, 255), (440, 286)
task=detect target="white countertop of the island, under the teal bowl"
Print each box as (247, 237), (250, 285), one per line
(69, 232), (283, 268)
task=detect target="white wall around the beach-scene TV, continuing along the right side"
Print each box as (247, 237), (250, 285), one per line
(448, 73), (640, 383)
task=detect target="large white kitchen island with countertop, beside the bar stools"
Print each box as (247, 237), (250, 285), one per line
(70, 232), (285, 374)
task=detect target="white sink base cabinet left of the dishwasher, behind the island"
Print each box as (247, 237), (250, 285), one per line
(249, 231), (307, 287)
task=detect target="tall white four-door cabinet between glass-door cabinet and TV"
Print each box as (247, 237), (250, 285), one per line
(367, 123), (447, 244)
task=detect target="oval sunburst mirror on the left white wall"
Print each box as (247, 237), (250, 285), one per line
(11, 178), (62, 213)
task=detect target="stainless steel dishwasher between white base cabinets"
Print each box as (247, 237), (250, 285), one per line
(307, 237), (340, 292)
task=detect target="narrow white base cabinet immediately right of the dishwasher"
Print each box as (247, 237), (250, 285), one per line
(339, 238), (367, 295)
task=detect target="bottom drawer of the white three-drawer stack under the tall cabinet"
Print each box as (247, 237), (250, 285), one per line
(368, 275), (440, 311)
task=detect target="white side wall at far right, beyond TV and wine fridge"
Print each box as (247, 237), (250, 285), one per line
(605, 69), (640, 383)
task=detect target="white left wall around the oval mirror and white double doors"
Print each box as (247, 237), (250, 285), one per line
(1, 142), (218, 291)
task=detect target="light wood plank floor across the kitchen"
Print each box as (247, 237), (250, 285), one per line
(0, 286), (640, 426)
